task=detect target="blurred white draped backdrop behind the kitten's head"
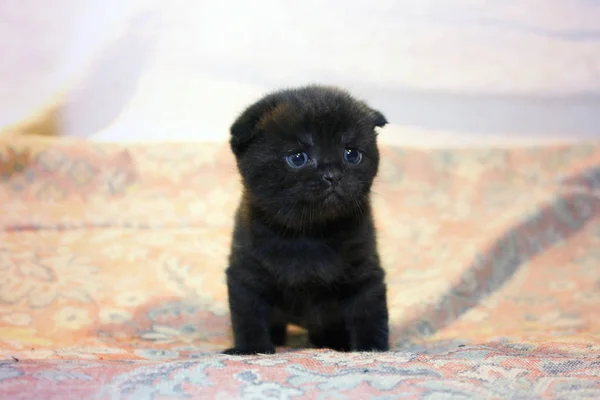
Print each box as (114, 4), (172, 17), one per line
(0, 0), (600, 147)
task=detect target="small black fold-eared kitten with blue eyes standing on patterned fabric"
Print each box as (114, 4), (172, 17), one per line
(225, 86), (388, 354)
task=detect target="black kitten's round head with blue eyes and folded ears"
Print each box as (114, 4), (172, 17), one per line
(230, 86), (387, 225)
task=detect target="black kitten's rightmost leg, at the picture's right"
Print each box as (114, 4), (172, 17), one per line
(344, 279), (389, 351)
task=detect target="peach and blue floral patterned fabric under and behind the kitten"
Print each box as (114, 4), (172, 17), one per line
(0, 138), (600, 399)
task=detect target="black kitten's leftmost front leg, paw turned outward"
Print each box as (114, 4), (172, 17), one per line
(224, 273), (275, 354)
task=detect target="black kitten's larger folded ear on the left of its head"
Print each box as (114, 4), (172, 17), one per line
(229, 98), (276, 156)
